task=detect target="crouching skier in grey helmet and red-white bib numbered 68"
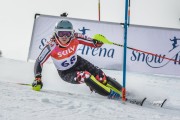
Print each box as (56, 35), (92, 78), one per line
(32, 20), (122, 98)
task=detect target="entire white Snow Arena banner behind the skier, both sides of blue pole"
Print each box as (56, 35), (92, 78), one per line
(28, 15), (180, 76)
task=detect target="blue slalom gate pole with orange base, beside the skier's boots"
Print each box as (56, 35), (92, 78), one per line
(122, 0), (128, 101)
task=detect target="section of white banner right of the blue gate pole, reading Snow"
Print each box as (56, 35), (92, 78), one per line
(127, 26), (180, 76)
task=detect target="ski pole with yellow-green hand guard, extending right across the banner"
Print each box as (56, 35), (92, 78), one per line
(93, 34), (180, 63)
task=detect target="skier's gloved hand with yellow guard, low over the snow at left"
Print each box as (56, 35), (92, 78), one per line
(32, 77), (43, 91)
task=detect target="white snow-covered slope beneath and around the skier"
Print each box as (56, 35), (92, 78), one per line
(0, 57), (180, 120)
